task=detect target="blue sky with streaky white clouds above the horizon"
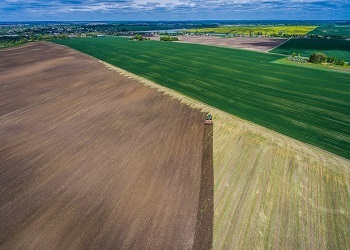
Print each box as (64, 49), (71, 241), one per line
(0, 0), (350, 21)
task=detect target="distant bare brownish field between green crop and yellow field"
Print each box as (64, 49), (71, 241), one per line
(178, 36), (287, 52)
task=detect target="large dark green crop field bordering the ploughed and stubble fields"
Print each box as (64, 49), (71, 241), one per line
(56, 37), (350, 159)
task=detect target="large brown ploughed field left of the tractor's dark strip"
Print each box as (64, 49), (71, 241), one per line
(0, 43), (208, 249)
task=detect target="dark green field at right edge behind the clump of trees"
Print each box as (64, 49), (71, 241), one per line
(270, 39), (350, 61)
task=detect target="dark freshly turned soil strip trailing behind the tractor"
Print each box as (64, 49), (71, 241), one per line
(193, 125), (214, 249)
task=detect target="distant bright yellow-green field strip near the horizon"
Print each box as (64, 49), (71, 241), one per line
(187, 26), (316, 36)
